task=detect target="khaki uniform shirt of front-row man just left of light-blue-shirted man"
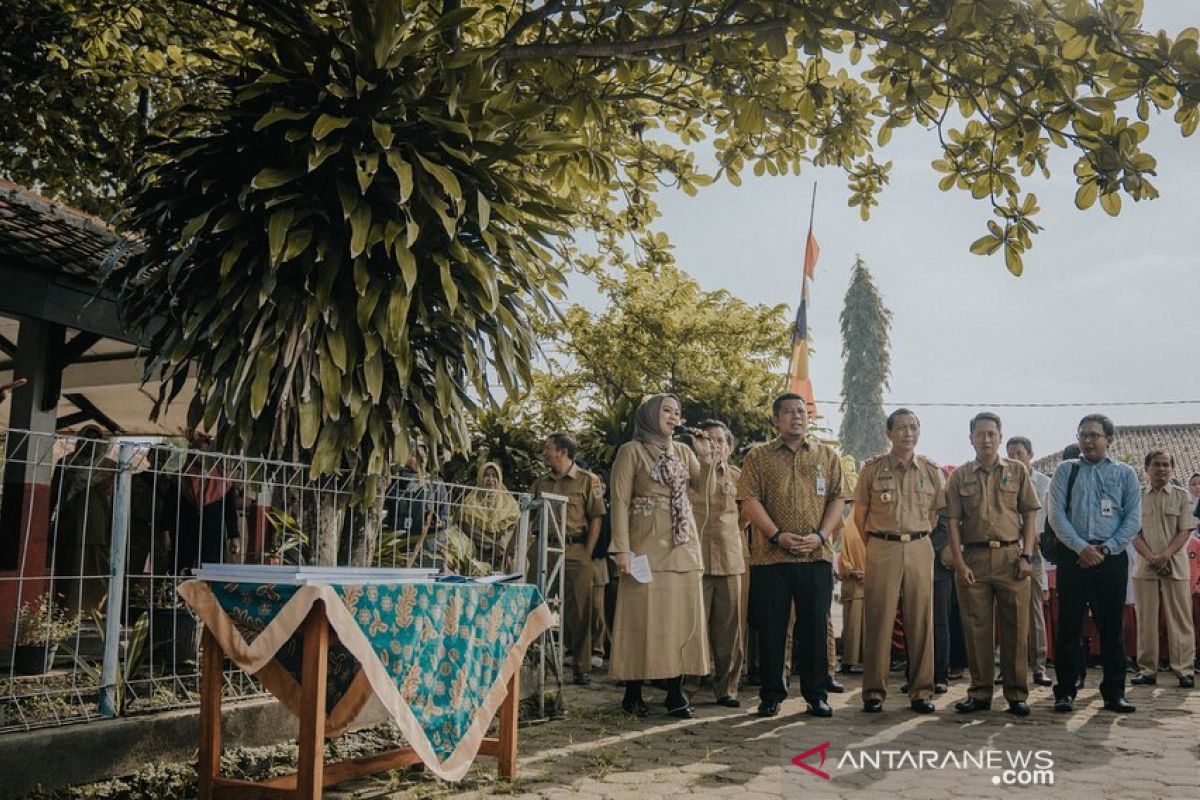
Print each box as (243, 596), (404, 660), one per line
(943, 457), (1042, 545)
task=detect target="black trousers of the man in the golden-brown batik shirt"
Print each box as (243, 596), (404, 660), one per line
(750, 561), (833, 703)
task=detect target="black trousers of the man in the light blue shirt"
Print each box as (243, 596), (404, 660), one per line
(1054, 553), (1129, 700)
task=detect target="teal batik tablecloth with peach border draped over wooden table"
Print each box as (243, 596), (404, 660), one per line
(179, 581), (551, 781)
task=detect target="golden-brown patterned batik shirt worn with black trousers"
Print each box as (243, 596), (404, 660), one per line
(737, 437), (850, 566)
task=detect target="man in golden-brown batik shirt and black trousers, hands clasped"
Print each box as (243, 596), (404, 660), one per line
(738, 392), (848, 717)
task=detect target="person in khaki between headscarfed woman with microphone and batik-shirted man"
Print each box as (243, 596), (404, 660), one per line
(688, 420), (746, 708)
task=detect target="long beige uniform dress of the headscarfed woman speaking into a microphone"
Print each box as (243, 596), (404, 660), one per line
(608, 441), (712, 680)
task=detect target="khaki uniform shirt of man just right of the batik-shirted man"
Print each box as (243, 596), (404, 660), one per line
(854, 453), (946, 540)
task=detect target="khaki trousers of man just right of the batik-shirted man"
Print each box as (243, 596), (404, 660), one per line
(863, 536), (934, 700)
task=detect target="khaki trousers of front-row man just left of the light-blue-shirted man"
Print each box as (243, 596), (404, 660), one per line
(954, 546), (1031, 703)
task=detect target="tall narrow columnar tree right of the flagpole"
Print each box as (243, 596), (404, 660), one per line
(838, 258), (892, 462)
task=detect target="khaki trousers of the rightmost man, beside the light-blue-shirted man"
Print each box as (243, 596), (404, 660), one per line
(1133, 578), (1196, 678)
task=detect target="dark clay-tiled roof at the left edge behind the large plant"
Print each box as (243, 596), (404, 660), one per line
(0, 181), (137, 283)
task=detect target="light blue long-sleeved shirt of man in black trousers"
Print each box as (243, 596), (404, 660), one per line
(1050, 456), (1141, 554)
